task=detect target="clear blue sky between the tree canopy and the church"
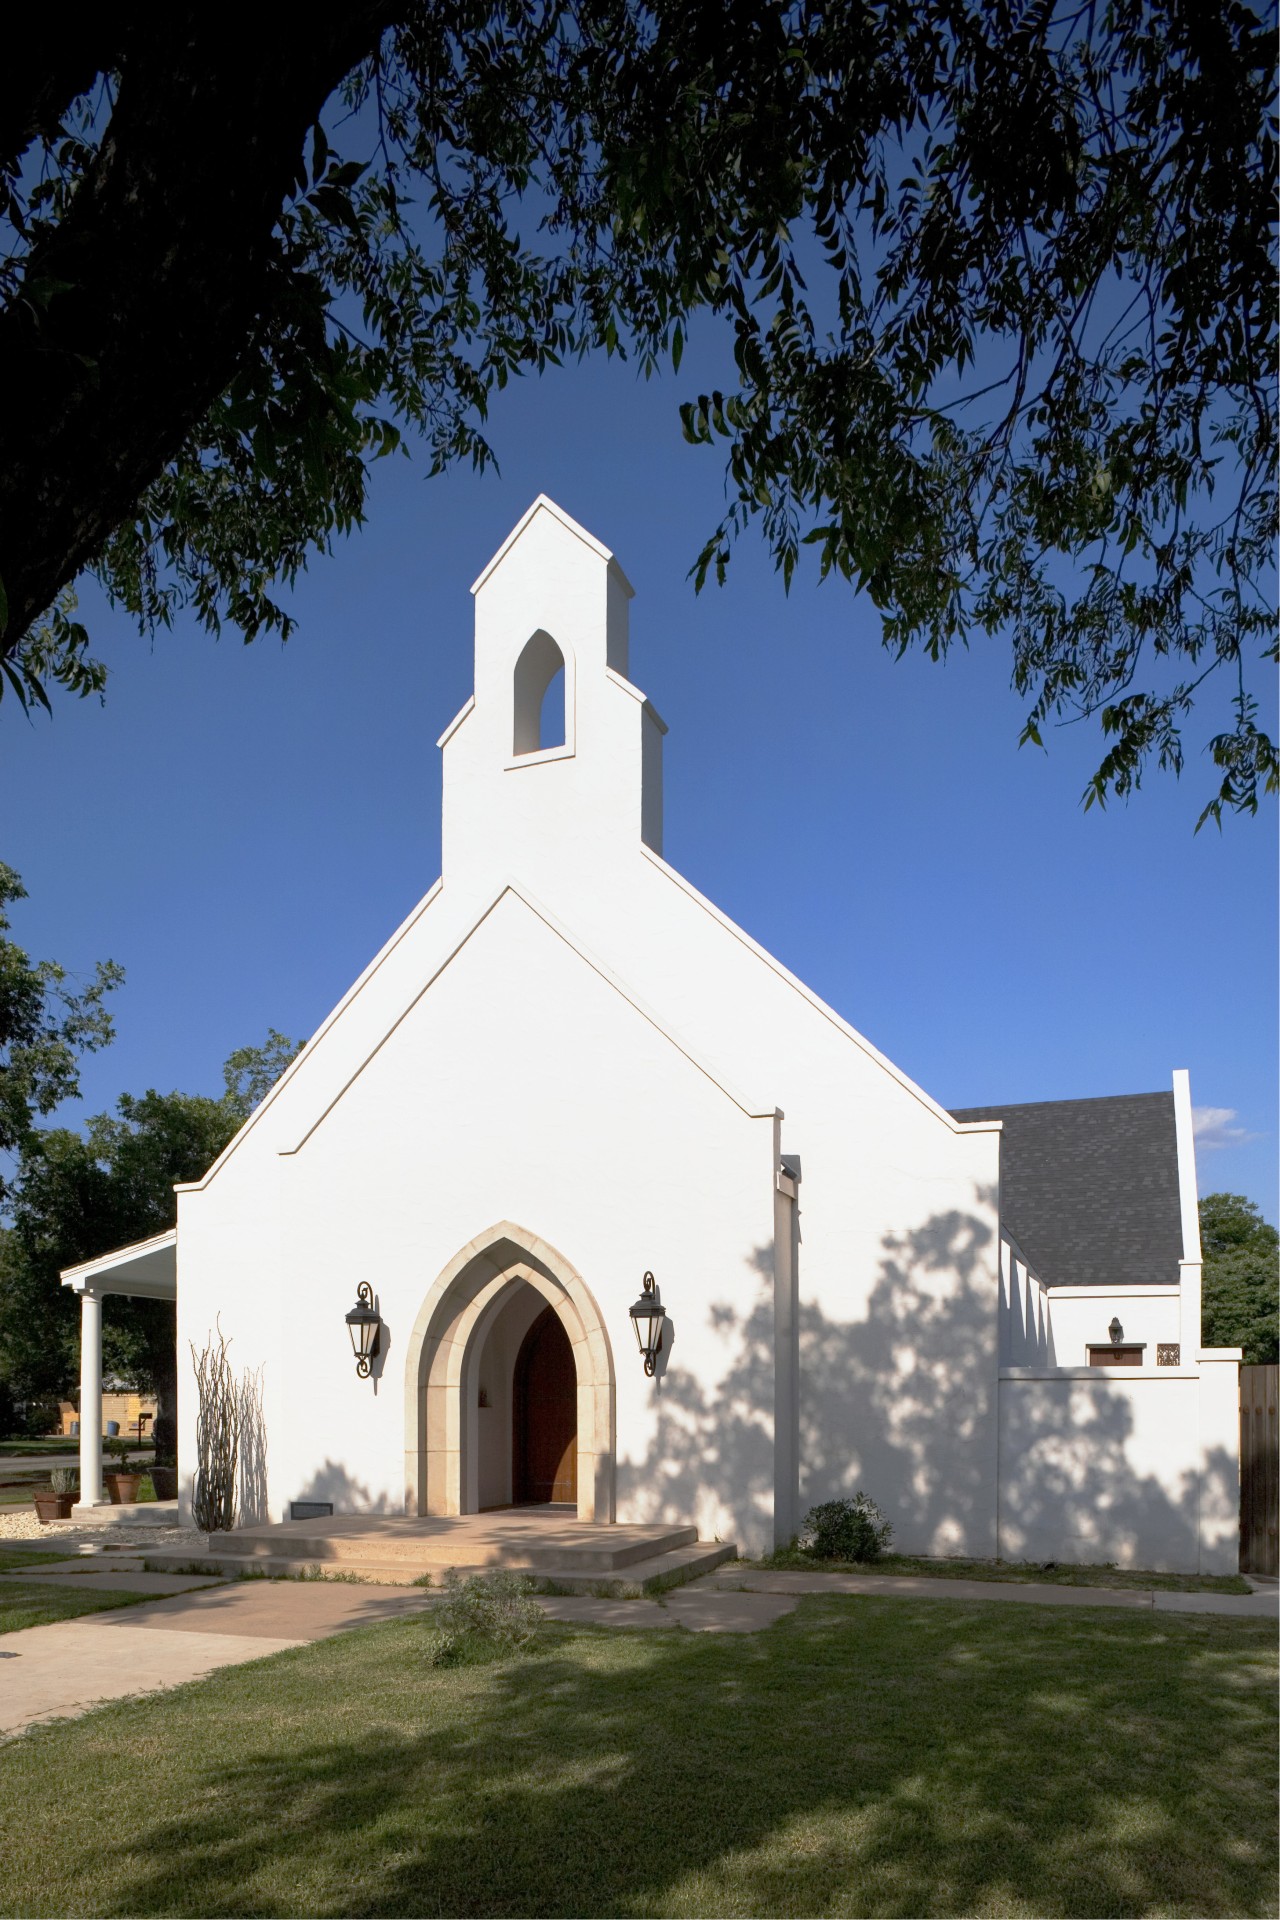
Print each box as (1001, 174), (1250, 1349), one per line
(0, 332), (1276, 1219)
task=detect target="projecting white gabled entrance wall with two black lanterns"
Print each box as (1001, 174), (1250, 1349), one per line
(180, 893), (775, 1546)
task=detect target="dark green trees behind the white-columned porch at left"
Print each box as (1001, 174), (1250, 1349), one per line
(0, 1027), (303, 1423)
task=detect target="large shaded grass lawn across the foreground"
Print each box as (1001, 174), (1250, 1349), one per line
(0, 1596), (1276, 1916)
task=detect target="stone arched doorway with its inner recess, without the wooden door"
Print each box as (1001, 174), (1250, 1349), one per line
(405, 1221), (614, 1521)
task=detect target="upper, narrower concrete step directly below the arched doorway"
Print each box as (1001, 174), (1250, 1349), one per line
(175, 1515), (699, 1576)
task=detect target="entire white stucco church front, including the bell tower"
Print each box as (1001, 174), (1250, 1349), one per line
(169, 503), (1228, 1553)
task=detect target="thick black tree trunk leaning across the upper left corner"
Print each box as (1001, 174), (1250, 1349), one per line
(0, 0), (395, 653)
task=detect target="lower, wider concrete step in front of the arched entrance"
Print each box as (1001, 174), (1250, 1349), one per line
(144, 1528), (737, 1597)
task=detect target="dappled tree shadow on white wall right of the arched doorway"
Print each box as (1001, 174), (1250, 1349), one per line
(620, 1194), (1232, 1567)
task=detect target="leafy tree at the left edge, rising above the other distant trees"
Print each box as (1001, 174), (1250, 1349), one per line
(0, 862), (125, 1206)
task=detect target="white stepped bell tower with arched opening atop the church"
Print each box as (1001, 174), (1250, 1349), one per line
(439, 493), (666, 887)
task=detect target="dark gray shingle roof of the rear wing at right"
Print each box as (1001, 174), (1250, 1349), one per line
(952, 1092), (1182, 1286)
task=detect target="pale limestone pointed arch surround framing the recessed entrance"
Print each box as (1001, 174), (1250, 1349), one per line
(405, 1221), (616, 1523)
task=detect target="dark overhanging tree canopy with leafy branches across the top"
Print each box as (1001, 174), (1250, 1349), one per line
(0, 0), (1276, 822)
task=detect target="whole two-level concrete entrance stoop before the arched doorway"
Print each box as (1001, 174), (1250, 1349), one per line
(146, 1507), (737, 1596)
